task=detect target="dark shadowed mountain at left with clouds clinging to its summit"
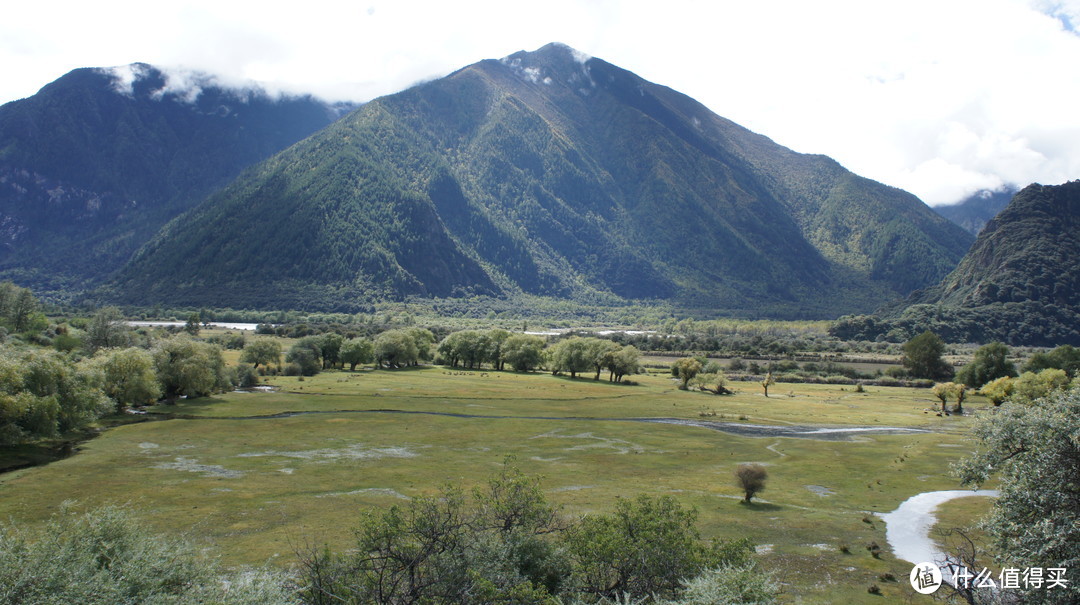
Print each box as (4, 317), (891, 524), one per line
(0, 64), (345, 291)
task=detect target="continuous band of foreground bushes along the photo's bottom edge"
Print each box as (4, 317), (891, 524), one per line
(0, 460), (780, 605)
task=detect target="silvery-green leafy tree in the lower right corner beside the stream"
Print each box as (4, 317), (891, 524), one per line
(954, 390), (1080, 604)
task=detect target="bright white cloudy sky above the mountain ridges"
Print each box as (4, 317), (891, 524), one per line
(0, 0), (1080, 205)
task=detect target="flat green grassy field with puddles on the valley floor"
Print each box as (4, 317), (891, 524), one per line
(0, 360), (983, 603)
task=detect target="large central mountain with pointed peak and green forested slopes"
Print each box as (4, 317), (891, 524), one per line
(102, 44), (971, 318)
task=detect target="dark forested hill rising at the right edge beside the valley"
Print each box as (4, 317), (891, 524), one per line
(838, 180), (1080, 347)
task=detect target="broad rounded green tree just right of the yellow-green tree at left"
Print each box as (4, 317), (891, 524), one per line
(152, 335), (230, 399)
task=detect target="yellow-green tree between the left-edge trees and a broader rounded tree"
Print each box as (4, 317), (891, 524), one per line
(84, 347), (161, 412)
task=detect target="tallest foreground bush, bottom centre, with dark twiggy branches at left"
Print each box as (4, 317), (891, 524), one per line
(301, 461), (566, 605)
